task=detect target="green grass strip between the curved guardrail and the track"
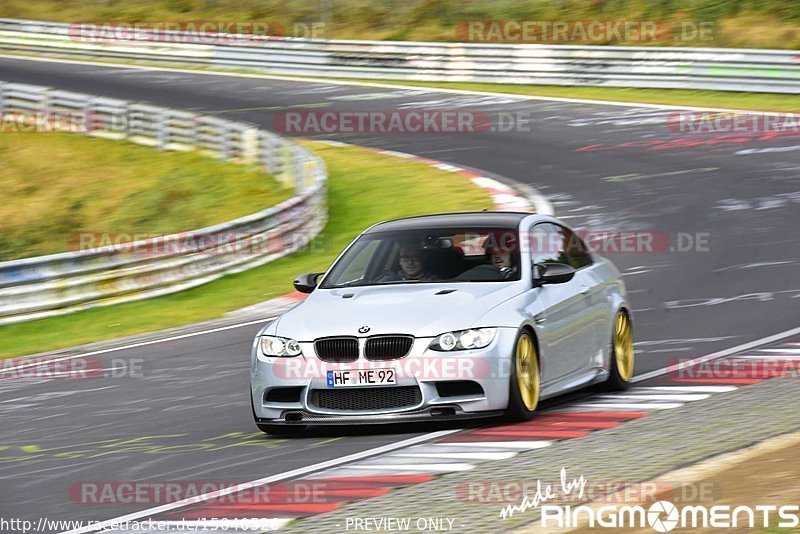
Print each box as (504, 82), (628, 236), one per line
(0, 143), (492, 357)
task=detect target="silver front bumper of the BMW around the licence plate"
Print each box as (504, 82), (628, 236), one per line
(250, 328), (517, 425)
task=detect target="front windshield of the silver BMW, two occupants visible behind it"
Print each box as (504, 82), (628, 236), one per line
(320, 228), (520, 289)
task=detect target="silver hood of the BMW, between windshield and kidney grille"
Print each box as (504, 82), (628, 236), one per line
(275, 282), (524, 341)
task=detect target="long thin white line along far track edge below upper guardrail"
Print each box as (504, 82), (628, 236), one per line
(0, 54), (780, 115)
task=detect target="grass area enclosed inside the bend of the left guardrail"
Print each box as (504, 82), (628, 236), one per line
(0, 133), (293, 261)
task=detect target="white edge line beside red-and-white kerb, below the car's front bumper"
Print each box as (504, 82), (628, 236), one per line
(62, 429), (460, 534)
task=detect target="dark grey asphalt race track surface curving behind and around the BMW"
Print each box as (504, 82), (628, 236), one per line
(0, 59), (800, 532)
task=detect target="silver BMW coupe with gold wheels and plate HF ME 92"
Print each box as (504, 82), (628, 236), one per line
(250, 212), (634, 432)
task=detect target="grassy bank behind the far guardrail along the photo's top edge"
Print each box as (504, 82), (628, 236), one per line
(0, 0), (800, 49)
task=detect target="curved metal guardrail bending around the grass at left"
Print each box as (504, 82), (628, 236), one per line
(0, 82), (327, 324)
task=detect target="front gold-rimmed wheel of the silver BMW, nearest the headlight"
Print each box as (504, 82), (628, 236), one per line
(506, 330), (541, 421)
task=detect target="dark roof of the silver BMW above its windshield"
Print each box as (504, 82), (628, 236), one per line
(364, 211), (531, 234)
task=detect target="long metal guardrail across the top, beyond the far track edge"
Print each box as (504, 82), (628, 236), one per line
(0, 19), (800, 93)
